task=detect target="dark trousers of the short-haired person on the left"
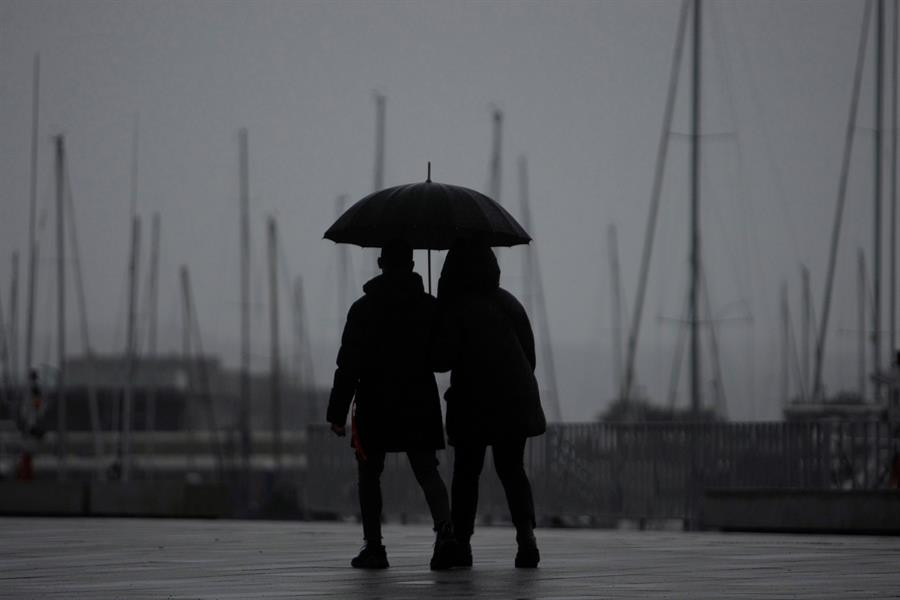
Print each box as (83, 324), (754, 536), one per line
(356, 450), (450, 543)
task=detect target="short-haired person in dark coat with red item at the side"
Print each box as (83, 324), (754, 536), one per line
(327, 243), (455, 569)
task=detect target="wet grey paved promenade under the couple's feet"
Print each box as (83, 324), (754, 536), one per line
(0, 518), (900, 599)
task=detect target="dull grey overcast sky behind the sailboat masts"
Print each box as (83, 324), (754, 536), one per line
(0, 0), (892, 420)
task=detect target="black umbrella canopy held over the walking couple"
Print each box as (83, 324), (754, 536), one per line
(325, 177), (531, 250)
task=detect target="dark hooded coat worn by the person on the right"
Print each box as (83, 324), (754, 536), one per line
(432, 244), (547, 446)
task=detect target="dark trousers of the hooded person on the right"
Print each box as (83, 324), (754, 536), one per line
(450, 438), (535, 541)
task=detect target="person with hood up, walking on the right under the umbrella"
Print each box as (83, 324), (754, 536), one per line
(433, 243), (546, 568)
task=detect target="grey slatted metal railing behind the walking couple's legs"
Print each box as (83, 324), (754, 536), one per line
(304, 421), (900, 522)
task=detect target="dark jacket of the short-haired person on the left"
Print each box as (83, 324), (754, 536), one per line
(327, 272), (444, 451)
